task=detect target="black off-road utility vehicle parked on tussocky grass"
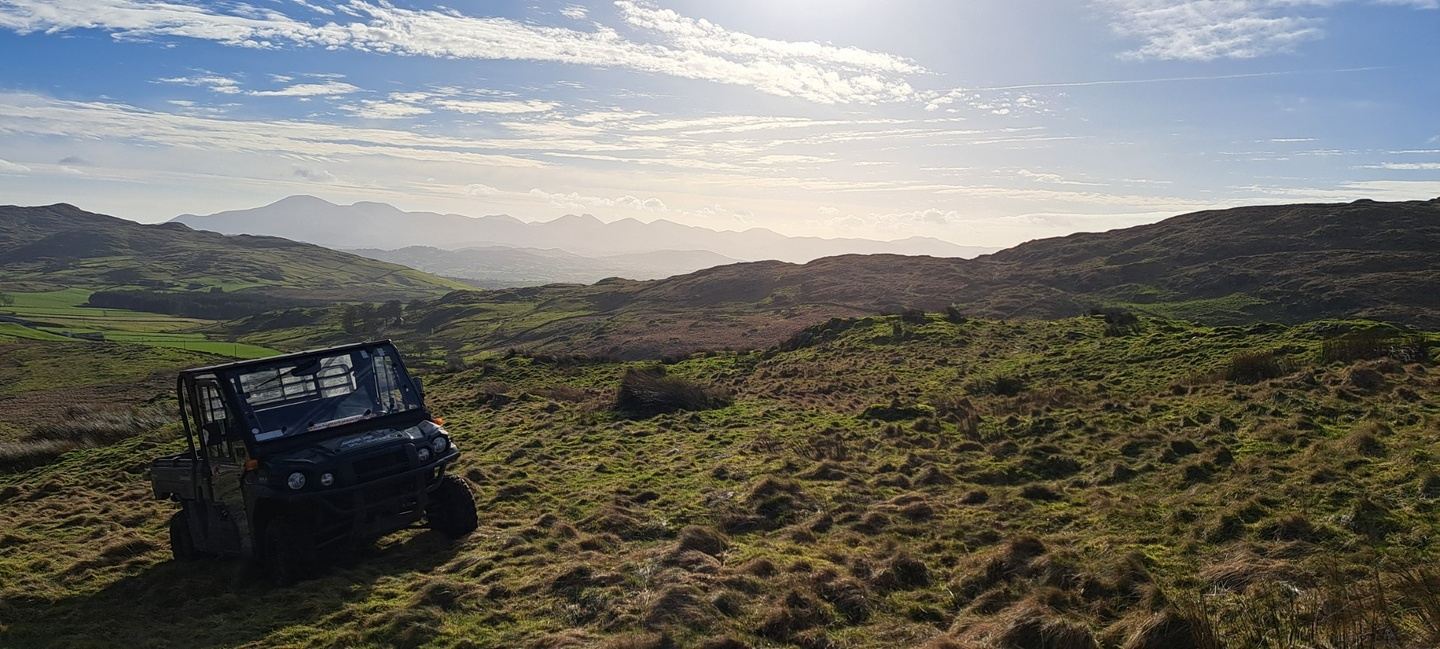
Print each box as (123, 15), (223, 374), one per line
(150, 341), (477, 584)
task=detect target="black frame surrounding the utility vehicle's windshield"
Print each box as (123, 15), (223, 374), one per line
(216, 342), (429, 449)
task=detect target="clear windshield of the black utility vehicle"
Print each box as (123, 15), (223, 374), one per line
(230, 347), (420, 442)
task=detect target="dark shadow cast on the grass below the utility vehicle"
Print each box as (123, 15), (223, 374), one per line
(0, 531), (459, 649)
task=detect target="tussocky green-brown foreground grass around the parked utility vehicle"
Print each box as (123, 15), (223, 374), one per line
(0, 314), (1440, 649)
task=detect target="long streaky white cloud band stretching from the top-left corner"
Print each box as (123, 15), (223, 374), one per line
(0, 0), (923, 104)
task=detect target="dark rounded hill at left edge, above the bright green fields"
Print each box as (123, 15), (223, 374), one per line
(0, 204), (462, 301)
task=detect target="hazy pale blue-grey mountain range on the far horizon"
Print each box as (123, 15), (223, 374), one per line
(174, 196), (994, 279)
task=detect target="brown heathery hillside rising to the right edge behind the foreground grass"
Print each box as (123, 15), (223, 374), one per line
(256, 200), (1440, 358)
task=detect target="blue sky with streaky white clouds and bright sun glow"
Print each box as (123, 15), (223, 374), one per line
(0, 0), (1440, 246)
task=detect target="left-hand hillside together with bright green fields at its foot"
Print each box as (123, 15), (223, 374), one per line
(0, 204), (462, 357)
